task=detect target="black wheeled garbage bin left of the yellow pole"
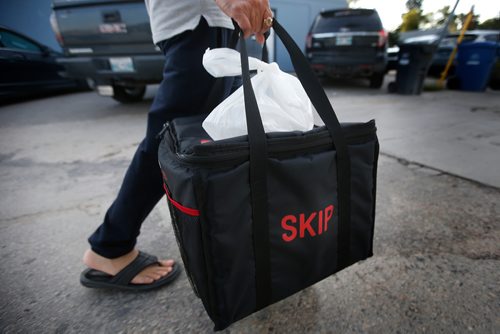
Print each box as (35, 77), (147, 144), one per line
(389, 44), (436, 95)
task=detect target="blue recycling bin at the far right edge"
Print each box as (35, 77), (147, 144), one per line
(456, 42), (499, 92)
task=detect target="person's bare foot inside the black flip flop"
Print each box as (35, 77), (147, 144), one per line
(83, 249), (174, 284)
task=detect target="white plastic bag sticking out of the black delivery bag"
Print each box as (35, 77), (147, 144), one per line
(203, 48), (314, 140)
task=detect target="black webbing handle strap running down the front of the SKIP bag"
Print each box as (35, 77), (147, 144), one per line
(240, 20), (352, 310)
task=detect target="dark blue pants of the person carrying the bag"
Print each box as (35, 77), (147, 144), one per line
(89, 18), (233, 258)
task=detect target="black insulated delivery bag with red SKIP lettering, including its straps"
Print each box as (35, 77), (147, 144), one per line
(159, 20), (378, 330)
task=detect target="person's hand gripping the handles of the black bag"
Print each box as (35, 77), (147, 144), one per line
(215, 0), (273, 44)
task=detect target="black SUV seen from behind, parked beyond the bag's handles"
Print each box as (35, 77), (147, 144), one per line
(306, 8), (387, 88)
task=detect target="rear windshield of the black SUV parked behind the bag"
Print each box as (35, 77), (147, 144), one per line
(312, 9), (382, 33)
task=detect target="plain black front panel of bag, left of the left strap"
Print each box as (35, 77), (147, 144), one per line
(205, 162), (256, 328)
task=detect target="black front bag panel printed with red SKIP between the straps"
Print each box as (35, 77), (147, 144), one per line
(268, 151), (338, 302)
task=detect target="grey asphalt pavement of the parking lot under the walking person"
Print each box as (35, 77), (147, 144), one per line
(0, 78), (500, 333)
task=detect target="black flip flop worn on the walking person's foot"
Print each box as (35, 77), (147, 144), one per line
(80, 252), (181, 291)
